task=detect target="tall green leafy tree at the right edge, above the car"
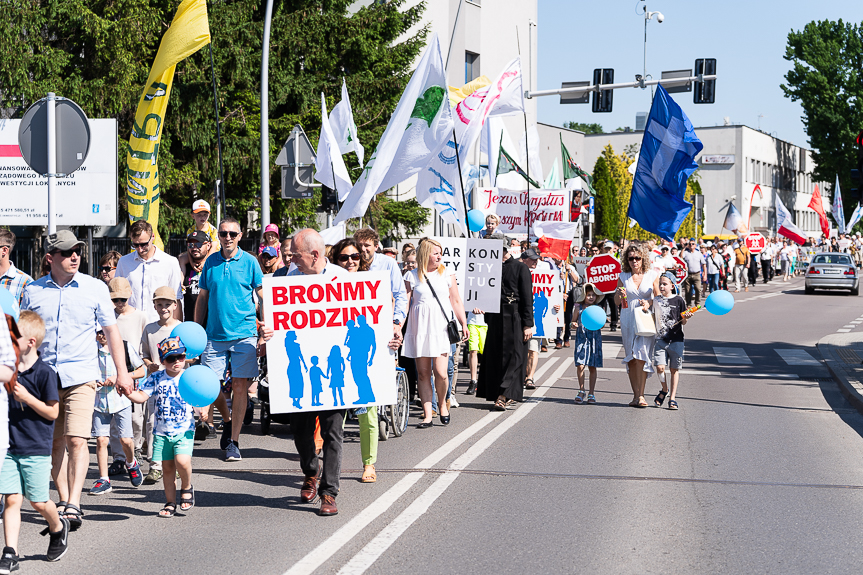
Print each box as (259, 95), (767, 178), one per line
(781, 20), (863, 219)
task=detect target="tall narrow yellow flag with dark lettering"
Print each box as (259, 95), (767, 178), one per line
(126, 0), (210, 249)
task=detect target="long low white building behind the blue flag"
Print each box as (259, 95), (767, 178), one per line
(582, 125), (832, 241)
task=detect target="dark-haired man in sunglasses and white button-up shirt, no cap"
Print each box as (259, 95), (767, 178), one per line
(114, 220), (183, 322)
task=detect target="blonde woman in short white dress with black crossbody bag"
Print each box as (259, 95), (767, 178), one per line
(402, 239), (467, 429)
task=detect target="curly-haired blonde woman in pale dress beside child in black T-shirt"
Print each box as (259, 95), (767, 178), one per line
(614, 242), (659, 407)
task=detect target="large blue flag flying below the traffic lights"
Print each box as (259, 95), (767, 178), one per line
(627, 86), (704, 241)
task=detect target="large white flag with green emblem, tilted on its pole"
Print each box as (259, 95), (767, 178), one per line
(334, 34), (453, 224)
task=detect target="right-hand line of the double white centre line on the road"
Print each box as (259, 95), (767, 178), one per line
(338, 362), (569, 575)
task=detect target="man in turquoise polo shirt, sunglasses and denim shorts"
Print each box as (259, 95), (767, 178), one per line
(195, 218), (272, 461)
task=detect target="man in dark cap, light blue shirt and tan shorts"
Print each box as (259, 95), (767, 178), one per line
(22, 230), (133, 529)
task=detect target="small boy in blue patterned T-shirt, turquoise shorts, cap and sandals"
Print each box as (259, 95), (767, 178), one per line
(129, 337), (195, 518)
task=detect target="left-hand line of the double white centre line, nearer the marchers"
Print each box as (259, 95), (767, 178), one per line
(285, 357), (569, 575)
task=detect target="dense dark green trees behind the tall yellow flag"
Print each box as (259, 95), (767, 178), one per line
(0, 0), (428, 238)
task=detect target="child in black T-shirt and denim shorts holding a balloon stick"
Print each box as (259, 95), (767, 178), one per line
(653, 274), (692, 409)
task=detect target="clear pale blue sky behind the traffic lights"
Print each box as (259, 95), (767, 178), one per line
(533, 0), (863, 148)
